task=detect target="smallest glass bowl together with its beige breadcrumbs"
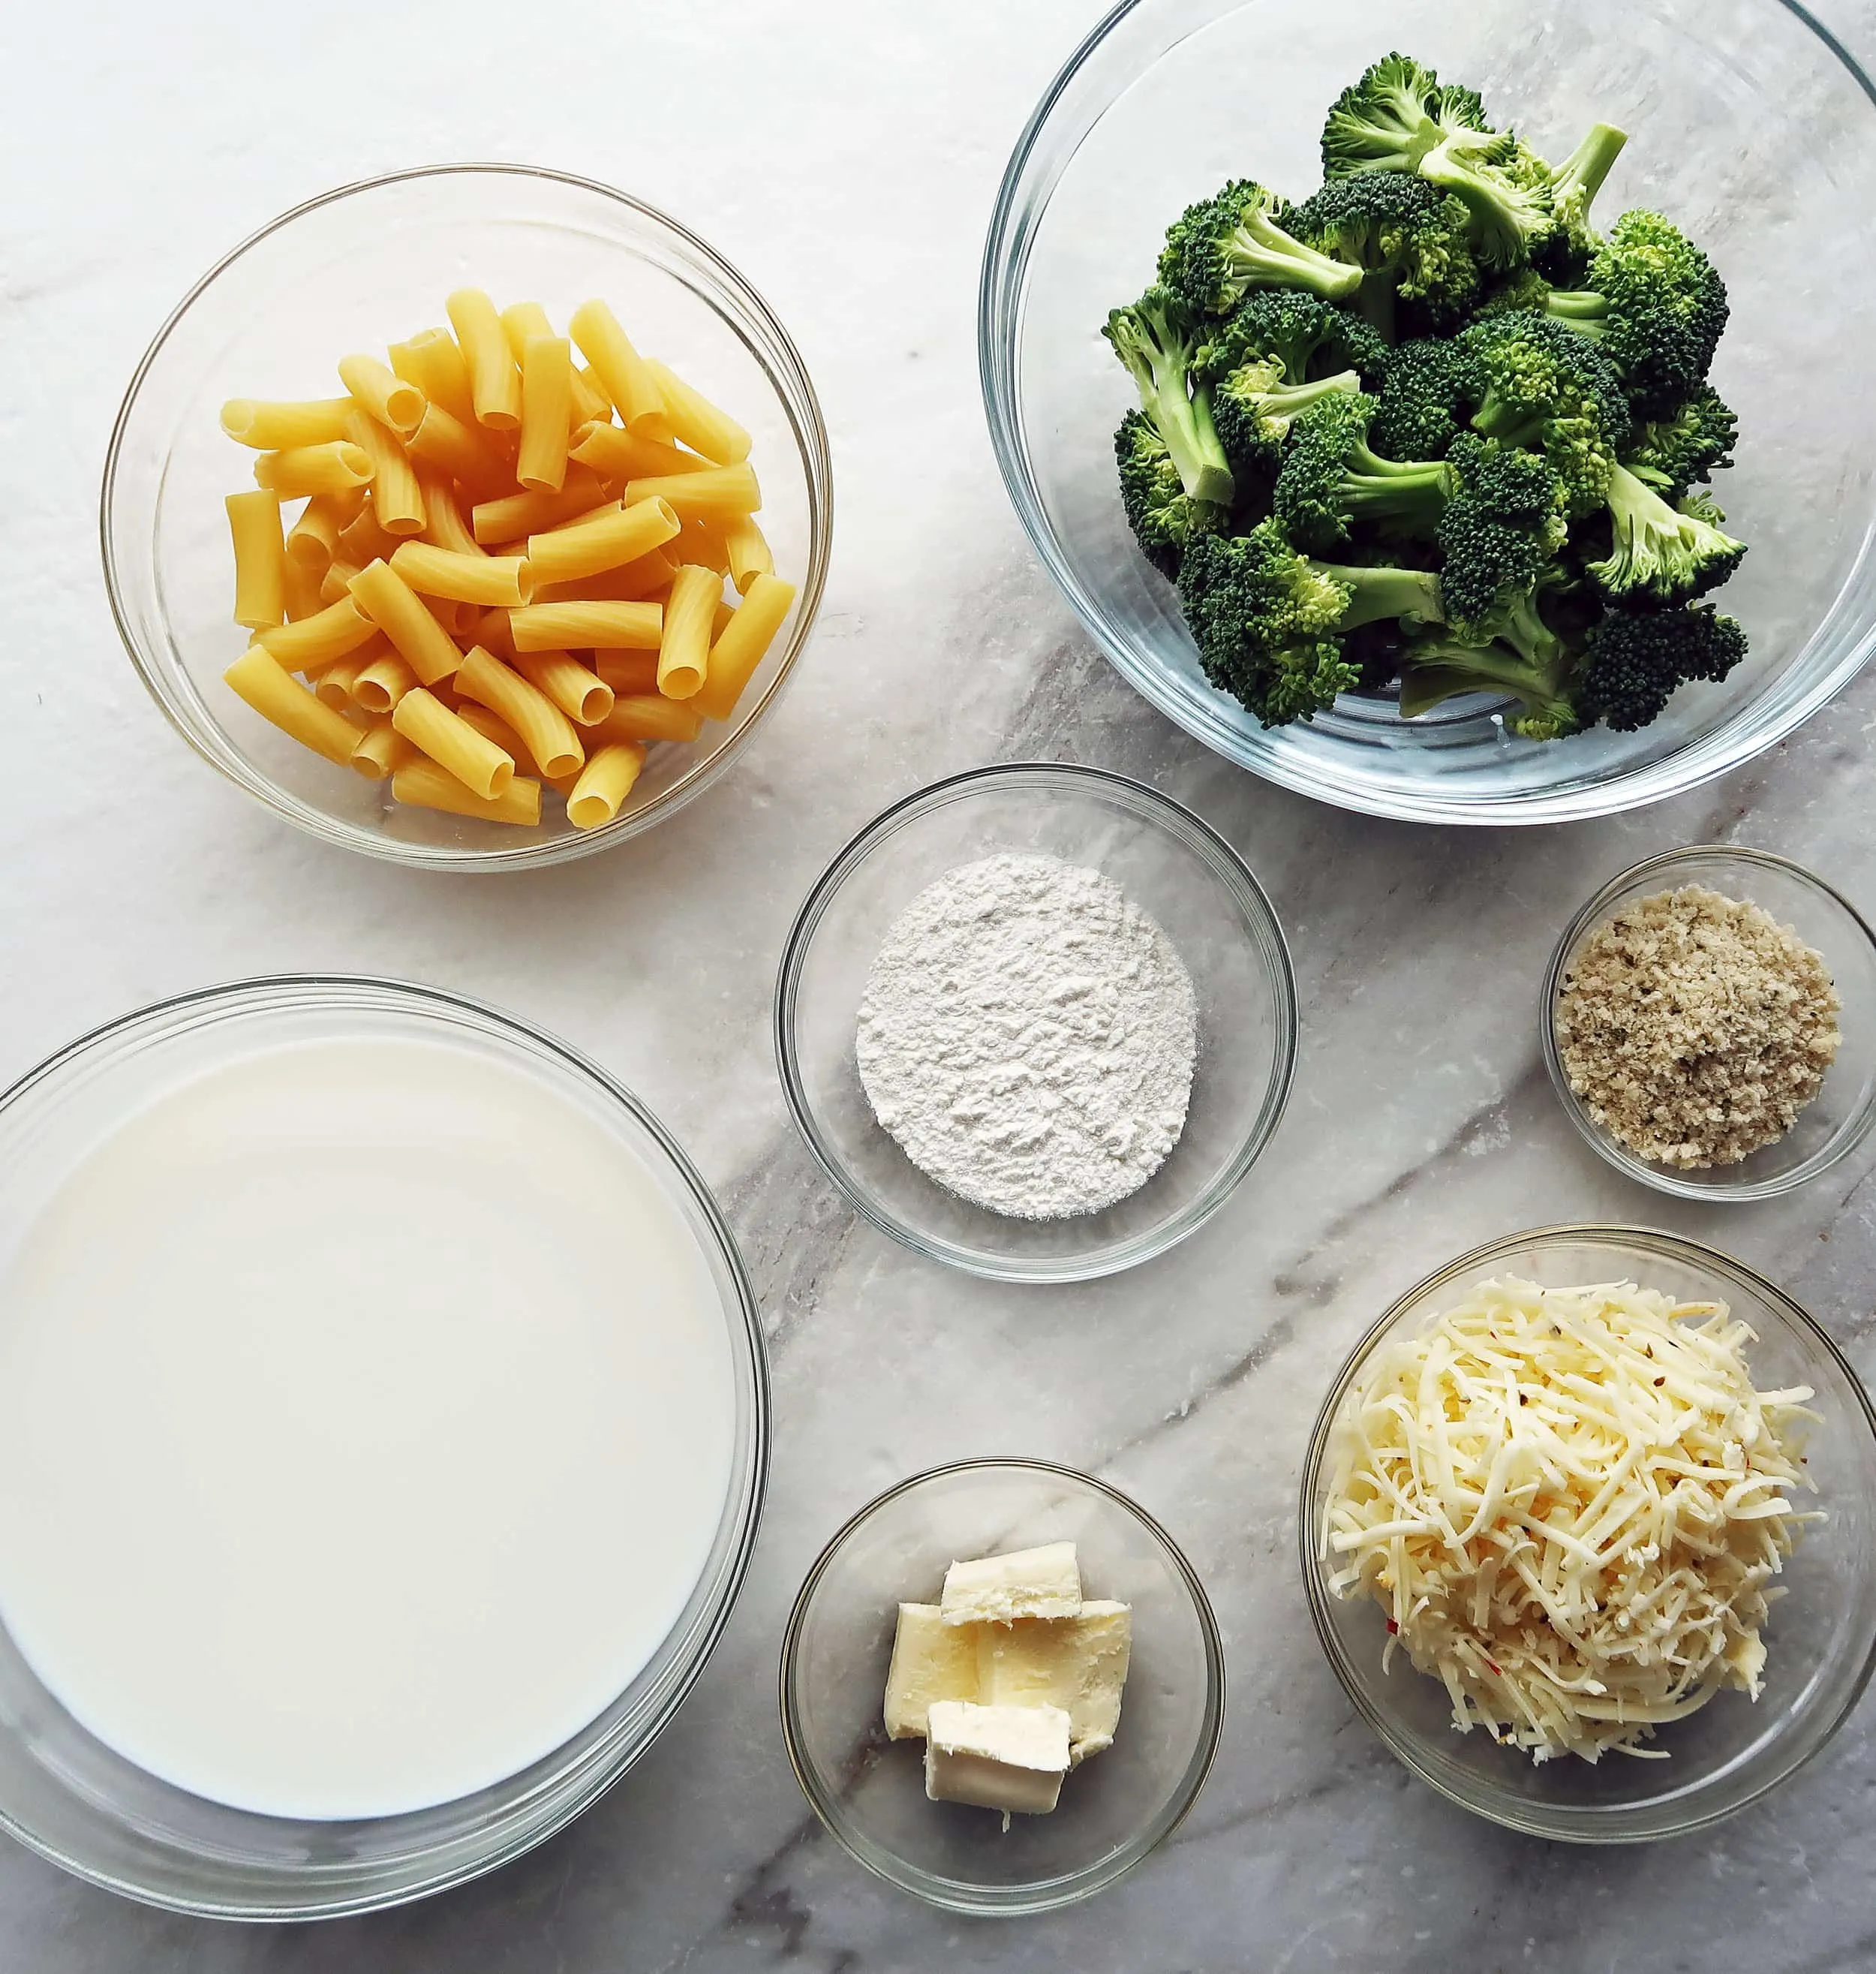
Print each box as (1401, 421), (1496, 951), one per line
(1543, 843), (1876, 1200)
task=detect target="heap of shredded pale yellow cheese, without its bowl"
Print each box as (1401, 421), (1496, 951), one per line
(1321, 1277), (1820, 1761)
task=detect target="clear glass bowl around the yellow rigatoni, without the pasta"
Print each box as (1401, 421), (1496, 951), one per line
(103, 164), (832, 871)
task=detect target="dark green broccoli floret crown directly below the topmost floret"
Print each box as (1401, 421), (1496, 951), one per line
(1290, 172), (1480, 339)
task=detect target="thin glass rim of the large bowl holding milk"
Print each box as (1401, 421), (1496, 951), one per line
(0, 971), (773, 1923)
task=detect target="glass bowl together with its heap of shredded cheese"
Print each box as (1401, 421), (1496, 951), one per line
(1300, 1226), (1876, 1843)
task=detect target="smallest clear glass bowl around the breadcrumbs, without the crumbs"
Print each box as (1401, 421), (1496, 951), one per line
(1538, 843), (1876, 1200)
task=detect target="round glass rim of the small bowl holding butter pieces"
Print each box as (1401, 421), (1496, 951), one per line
(777, 1455), (1227, 1918)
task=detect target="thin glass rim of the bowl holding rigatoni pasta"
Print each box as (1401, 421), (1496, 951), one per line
(98, 160), (834, 872)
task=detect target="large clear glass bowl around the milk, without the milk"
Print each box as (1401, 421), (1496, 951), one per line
(0, 975), (769, 1918)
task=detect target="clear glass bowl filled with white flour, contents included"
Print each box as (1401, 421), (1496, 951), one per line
(775, 764), (1296, 1281)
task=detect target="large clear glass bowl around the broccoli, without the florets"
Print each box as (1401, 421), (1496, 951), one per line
(979, 0), (1876, 823)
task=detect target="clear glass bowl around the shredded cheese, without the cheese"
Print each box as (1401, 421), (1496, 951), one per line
(1298, 1226), (1876, 1843)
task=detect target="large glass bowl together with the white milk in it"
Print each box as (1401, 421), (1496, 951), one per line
(0, 977), (769, 1918)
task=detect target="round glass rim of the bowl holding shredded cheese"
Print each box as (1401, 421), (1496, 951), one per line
(1296, 1220), (1876, 1843)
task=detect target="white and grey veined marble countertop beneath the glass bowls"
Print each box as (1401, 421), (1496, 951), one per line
(0, 0), (1876, 1974)
